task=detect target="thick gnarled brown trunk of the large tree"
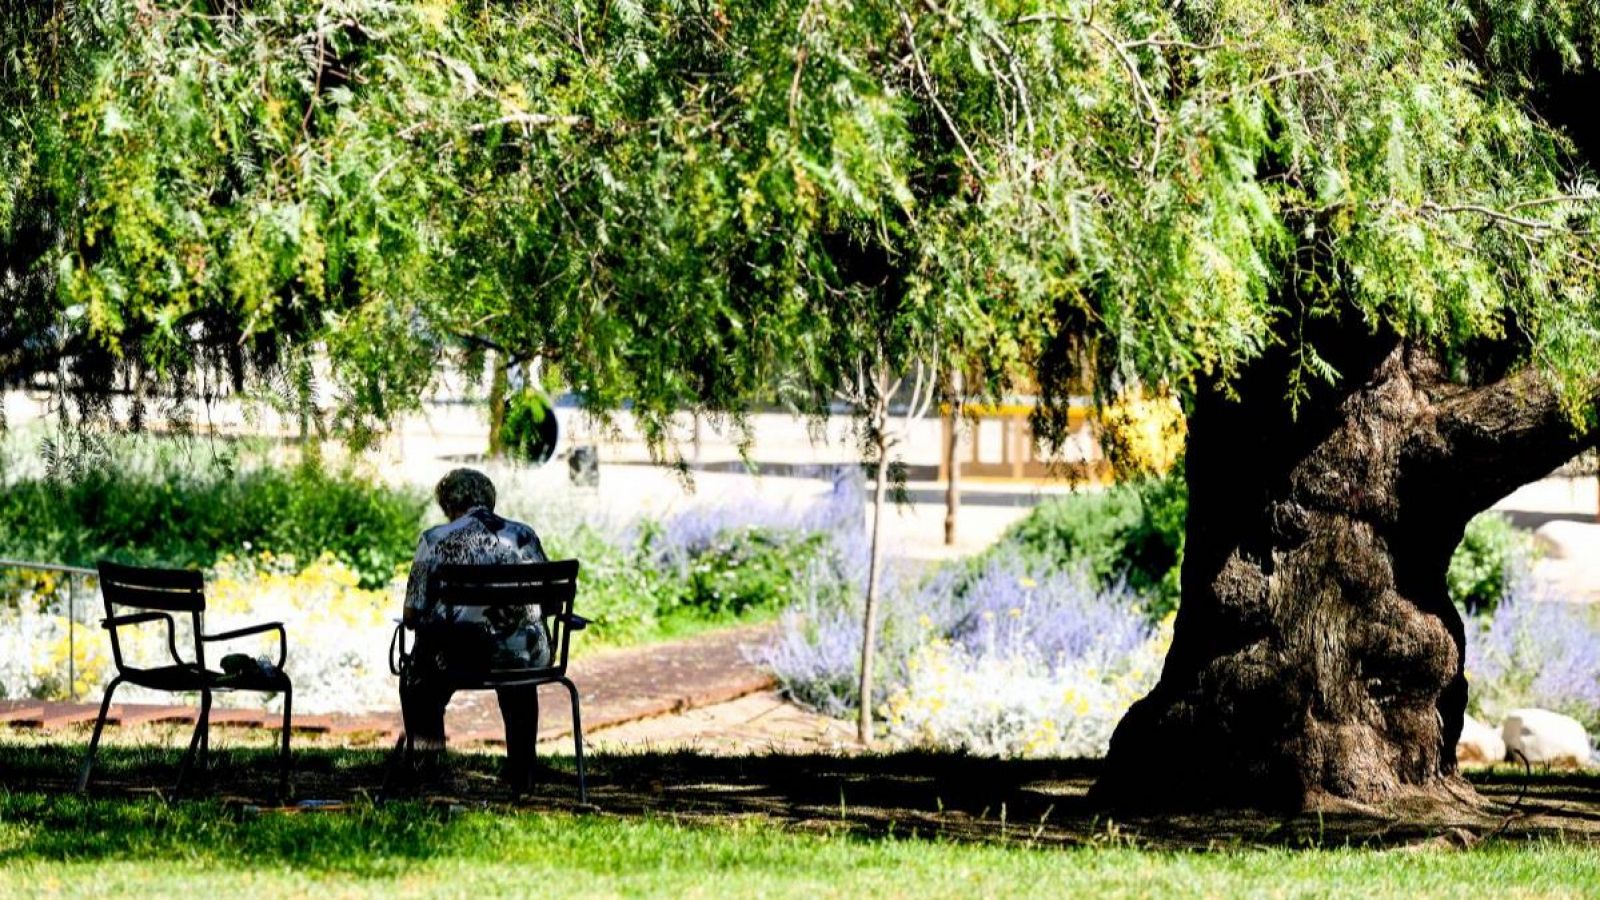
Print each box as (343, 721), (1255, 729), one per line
(1093, 333), (1592, 809)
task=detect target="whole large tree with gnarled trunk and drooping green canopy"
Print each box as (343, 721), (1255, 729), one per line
(9, 0), (1600, 806)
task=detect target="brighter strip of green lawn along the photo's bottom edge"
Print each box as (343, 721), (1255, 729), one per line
(0, 794), (1600, 897)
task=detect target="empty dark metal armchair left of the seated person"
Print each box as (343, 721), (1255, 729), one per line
(78, 560), (294, 794)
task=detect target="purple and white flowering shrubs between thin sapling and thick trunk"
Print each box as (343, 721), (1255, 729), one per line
(757, 552), (1171, 756)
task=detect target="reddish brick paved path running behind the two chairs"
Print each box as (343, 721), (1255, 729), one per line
(0, 625), (774, 746)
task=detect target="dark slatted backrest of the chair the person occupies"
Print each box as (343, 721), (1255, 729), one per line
(429, 559), (578, 674)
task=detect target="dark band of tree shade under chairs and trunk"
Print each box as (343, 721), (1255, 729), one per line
(0, 741), (1600, 870)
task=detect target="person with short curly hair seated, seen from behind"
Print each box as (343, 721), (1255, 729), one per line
(400, 469), (550, 790)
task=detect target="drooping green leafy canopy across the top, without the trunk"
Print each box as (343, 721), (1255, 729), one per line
(0, 0), (1600, 439)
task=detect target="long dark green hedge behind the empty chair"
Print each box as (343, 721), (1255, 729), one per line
(0, 455), (427, 588)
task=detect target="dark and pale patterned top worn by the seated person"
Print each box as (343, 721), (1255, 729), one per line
(405, 506), (550, 668)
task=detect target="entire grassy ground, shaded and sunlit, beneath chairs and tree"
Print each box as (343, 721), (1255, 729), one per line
(0, 738), (1600, 900)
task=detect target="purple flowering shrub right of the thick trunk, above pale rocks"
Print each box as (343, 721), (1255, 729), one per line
(1466, 578), (1600, 733)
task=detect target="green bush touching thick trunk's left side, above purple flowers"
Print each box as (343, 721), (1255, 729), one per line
(989, 468), (1189, 618)
